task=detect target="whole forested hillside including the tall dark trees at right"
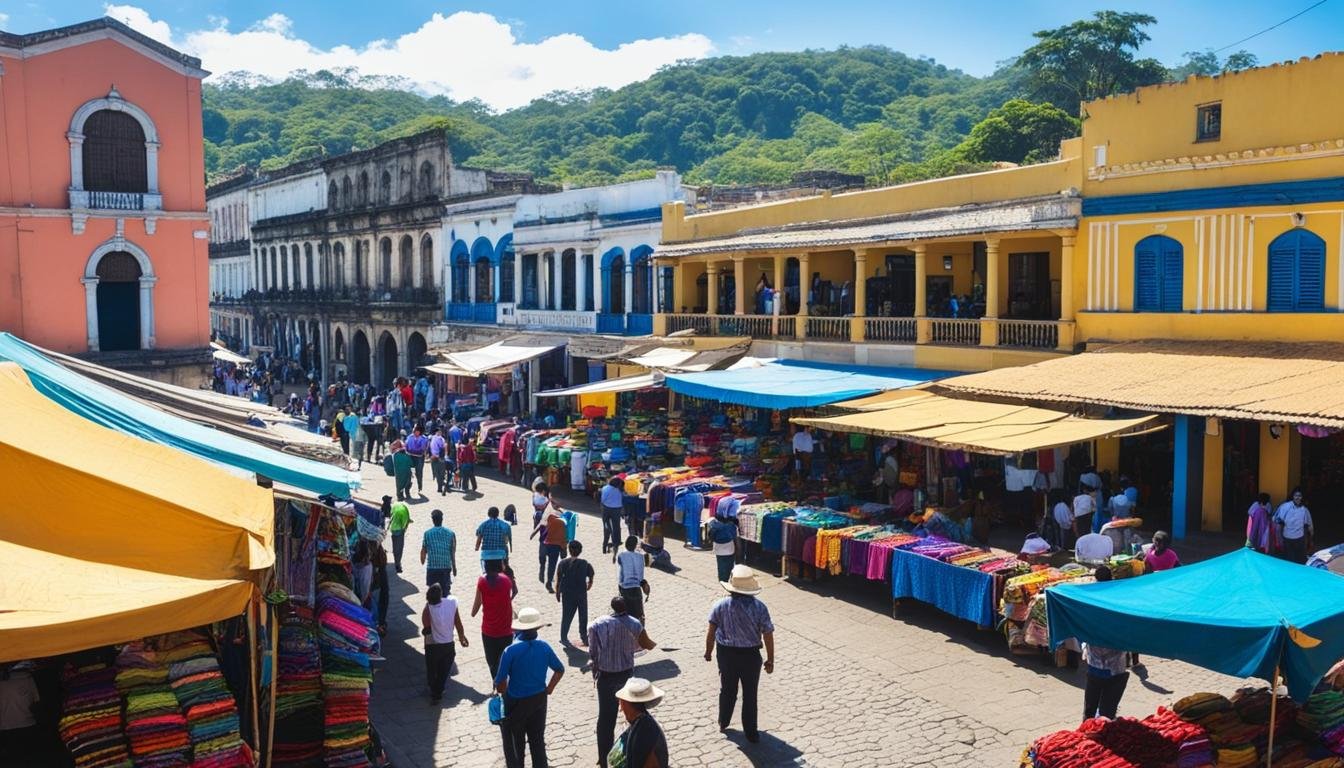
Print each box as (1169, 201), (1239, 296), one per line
(204, 11), (1255, 184)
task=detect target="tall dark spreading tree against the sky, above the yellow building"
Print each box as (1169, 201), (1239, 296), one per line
(1017, 11), (1167, 113)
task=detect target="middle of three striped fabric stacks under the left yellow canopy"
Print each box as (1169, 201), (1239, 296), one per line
(117, 642), (191, 768)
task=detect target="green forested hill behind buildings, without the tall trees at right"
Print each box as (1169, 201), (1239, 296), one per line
(204, 47), (1037, 184)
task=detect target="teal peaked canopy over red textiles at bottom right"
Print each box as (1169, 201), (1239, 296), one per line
(1046, 549), (1344, 701)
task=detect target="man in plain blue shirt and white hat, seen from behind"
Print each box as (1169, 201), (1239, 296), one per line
(495, 608), (564, 768)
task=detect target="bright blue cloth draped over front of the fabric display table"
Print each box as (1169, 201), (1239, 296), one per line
(891, 549), (995, 628)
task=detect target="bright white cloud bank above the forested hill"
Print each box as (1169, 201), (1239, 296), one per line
(106, 5), (714, 109)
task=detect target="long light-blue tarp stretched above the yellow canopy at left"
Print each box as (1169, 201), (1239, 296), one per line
(0, 332), (359, 499)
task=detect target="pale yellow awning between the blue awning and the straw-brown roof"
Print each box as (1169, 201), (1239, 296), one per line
(793, 393), (1157, 456)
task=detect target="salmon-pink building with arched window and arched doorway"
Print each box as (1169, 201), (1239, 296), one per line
(0, 19), (210, 385)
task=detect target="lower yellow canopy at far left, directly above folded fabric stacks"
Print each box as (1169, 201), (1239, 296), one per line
(0, 543), (253, 662)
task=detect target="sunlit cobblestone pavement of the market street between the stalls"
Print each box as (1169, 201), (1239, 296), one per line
(360, 464), (1239, 768)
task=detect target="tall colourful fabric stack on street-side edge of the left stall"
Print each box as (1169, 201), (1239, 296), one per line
(317, 582), (378, 768)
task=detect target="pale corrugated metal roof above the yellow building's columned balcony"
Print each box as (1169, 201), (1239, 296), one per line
(657, 194), (1082, 258)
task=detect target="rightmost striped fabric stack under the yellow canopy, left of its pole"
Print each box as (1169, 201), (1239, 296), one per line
(159, 635), (251, 768)
